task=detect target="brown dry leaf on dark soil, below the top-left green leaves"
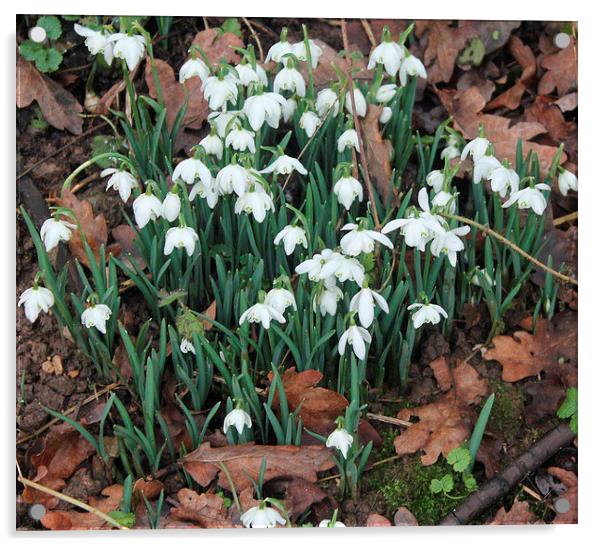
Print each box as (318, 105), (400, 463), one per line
(16, 53), (83, 135)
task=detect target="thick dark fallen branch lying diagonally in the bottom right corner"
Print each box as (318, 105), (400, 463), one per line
(439, 423), (575, 525)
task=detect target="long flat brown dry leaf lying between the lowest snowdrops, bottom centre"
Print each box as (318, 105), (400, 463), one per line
(182, 442), (335, 491)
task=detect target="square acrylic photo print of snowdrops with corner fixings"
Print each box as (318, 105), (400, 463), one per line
(16, 14), (578, 530)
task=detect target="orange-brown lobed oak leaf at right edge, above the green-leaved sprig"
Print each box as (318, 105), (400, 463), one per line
(483, 313), (577, 387)
